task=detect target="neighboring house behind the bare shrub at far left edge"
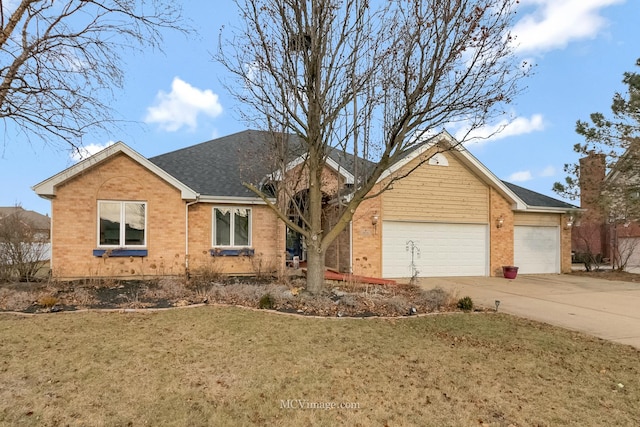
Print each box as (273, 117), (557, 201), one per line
(0, 206), (51, 261)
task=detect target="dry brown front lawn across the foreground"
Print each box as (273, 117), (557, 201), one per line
(0, 306), (640, 426)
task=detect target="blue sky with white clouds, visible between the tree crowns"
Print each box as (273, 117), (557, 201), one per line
(0, 0), (640, 213)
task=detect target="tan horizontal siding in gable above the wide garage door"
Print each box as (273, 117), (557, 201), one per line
(383, 153), (489, 223)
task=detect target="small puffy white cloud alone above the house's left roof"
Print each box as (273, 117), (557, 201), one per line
(144, 77), (222, 132)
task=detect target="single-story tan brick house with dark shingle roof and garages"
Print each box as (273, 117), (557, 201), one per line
(34, 131), (575, 278)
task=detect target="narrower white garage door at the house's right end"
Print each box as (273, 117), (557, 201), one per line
(513, 225), (560, 274)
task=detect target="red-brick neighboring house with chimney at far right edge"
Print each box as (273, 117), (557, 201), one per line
(572, 150), (640, 267)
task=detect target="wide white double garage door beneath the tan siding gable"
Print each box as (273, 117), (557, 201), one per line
(382, 221), (489, 277)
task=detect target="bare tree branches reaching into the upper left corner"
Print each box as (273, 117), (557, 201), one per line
(0, 0), (188, 154)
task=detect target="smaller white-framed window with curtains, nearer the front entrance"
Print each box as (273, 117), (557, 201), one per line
(213, 206), (251, 247)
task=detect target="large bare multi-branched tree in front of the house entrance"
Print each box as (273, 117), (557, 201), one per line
(216, 0), (528, 293)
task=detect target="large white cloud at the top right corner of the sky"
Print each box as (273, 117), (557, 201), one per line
(513, 0), (624, 52)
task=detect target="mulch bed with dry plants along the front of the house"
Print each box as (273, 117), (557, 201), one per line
(0, 278), (456, 317)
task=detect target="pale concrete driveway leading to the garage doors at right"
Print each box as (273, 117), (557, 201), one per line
(419, 274), (640, 349)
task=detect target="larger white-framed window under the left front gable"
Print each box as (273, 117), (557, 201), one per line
(98, 200), (147, 247)
